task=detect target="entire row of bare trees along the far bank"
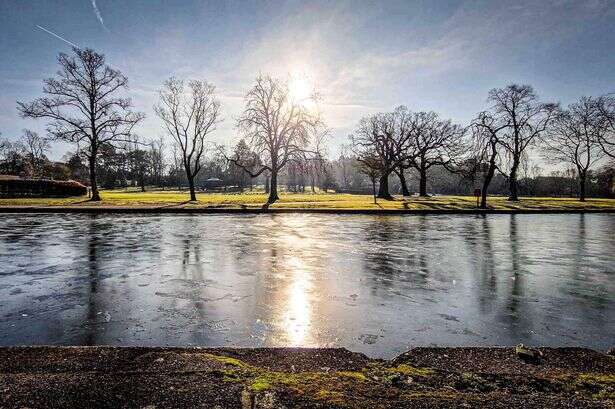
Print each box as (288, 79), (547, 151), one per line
(0, 48), (615, 207)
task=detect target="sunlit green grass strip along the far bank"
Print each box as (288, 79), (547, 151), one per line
(0, 190), (615, 210)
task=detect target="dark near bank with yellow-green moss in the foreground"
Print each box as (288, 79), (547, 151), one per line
(0, 346), (615, 409)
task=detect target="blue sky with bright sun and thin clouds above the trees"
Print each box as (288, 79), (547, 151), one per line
(0, 0), (615, 159)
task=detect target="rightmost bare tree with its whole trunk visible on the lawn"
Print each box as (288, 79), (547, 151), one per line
(543, 97), (606, 202)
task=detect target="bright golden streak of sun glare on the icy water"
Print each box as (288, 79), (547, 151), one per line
(246, 216), (330, 346)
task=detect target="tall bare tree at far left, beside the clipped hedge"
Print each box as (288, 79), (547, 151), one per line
(17, 48), (144, 201)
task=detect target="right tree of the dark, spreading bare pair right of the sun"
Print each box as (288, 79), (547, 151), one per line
(402, 112), (465, 196)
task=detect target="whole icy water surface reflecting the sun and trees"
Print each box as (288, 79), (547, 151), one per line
(0, 214), (615, 356)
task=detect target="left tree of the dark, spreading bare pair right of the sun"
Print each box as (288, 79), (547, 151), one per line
(350, 106), (413, 200)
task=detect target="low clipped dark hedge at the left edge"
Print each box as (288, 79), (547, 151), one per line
(0, 178), (87, 198)
